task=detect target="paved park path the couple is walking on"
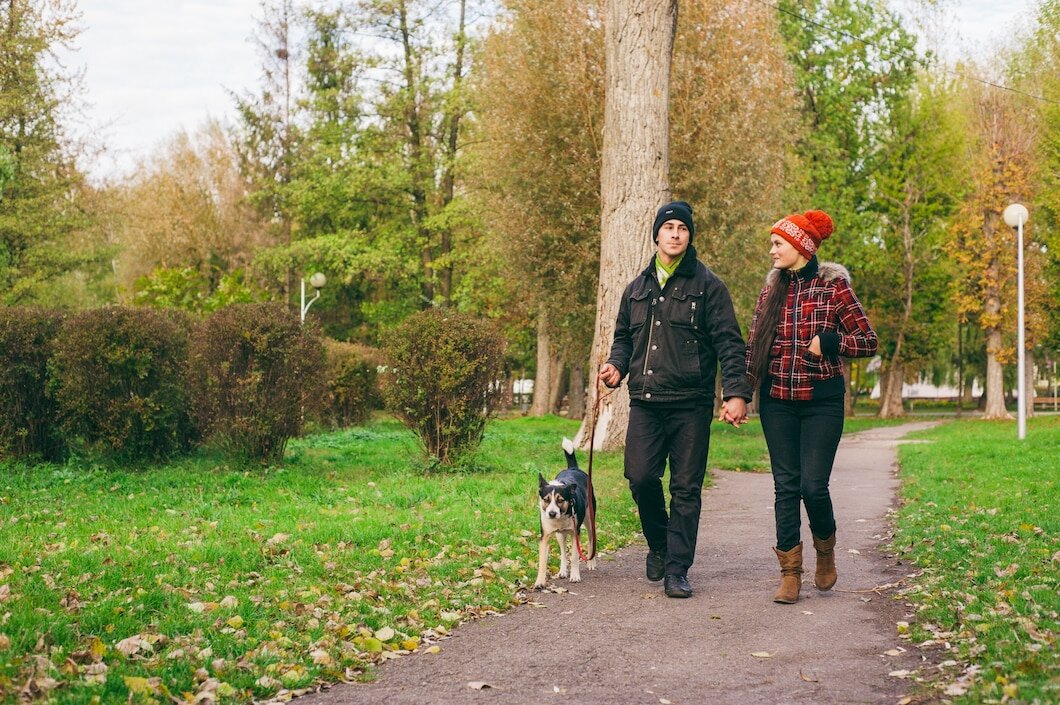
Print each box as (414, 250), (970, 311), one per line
(298, 422), (933, 705)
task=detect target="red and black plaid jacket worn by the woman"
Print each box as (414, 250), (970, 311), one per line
(747, 258), (878, 400)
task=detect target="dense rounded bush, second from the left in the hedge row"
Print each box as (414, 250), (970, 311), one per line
(50, 306), (194, 460)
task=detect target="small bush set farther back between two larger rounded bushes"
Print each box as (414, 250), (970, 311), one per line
(321, 339), (383, 428)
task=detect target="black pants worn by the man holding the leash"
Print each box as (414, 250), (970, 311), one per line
(625, 404), (713, 575)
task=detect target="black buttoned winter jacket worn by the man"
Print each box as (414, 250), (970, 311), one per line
(607, 246), (752, 403)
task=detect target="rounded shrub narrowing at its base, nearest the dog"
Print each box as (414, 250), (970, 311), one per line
(383, 309), (505, 465)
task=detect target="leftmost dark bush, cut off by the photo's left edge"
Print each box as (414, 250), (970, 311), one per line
(0, 307), (65, 460)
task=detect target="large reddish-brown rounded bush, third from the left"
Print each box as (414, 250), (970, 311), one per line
(191, 303), (324, 461)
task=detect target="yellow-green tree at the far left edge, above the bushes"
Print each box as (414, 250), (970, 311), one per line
(0, 0), (101, 304)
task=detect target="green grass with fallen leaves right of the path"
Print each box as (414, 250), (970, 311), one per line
(895, 417), (1060, 705)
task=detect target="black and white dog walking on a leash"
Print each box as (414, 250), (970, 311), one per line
(533, 438), (596, 588)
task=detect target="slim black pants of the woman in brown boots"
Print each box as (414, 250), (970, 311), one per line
(759, 393), (844, 551)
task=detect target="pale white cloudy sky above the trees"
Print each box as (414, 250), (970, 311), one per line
(65, 0), (1032, 178)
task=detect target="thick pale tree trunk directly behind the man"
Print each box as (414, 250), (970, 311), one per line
(578, 0), (677, 448)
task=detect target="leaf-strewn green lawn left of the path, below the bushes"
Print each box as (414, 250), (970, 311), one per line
(0, 409), (915, 703)
